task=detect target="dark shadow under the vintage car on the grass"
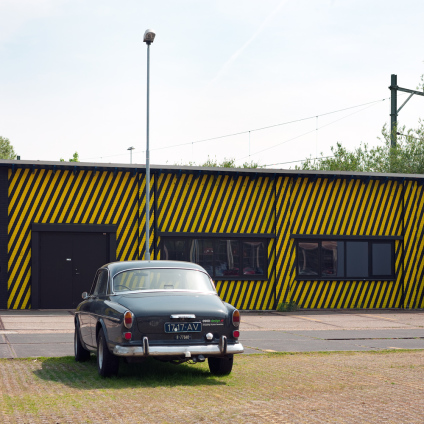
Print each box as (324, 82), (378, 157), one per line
(34, 355), (231, 390)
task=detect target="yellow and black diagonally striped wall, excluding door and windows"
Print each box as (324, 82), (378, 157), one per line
(0, 161), (424, 310)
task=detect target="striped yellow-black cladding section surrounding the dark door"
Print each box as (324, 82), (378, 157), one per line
(8, 168), (153, 309)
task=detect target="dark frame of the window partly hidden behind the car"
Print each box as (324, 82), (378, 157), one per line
(159, 234), (272, 281)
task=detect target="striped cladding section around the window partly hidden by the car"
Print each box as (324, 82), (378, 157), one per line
(157, 173), (275, 309)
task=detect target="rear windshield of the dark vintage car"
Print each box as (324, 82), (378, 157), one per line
(113, 268), (215, 293)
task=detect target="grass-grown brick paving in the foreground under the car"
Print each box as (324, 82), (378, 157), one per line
(0, 350), (424, 424)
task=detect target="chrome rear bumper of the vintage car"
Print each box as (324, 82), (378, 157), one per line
(113, 336), (244, 358)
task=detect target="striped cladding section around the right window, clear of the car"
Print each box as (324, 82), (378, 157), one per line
(277, 178), (412, 308)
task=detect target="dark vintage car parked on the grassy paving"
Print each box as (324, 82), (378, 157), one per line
(74, 261), (243, 377)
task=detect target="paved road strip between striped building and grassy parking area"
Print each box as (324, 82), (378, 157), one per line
(0, 310), (424, 358)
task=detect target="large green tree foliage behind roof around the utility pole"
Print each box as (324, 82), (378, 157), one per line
(296, 120), (424, 174)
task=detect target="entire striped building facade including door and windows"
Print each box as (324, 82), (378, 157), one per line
(0, 160), (424, 310)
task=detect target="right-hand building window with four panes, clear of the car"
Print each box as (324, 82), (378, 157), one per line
(296, 239), (395, 280)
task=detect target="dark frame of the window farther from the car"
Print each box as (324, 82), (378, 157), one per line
(292, 235), (401, 281)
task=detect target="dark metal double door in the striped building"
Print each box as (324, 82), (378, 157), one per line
(40, 232), (109, 309)
